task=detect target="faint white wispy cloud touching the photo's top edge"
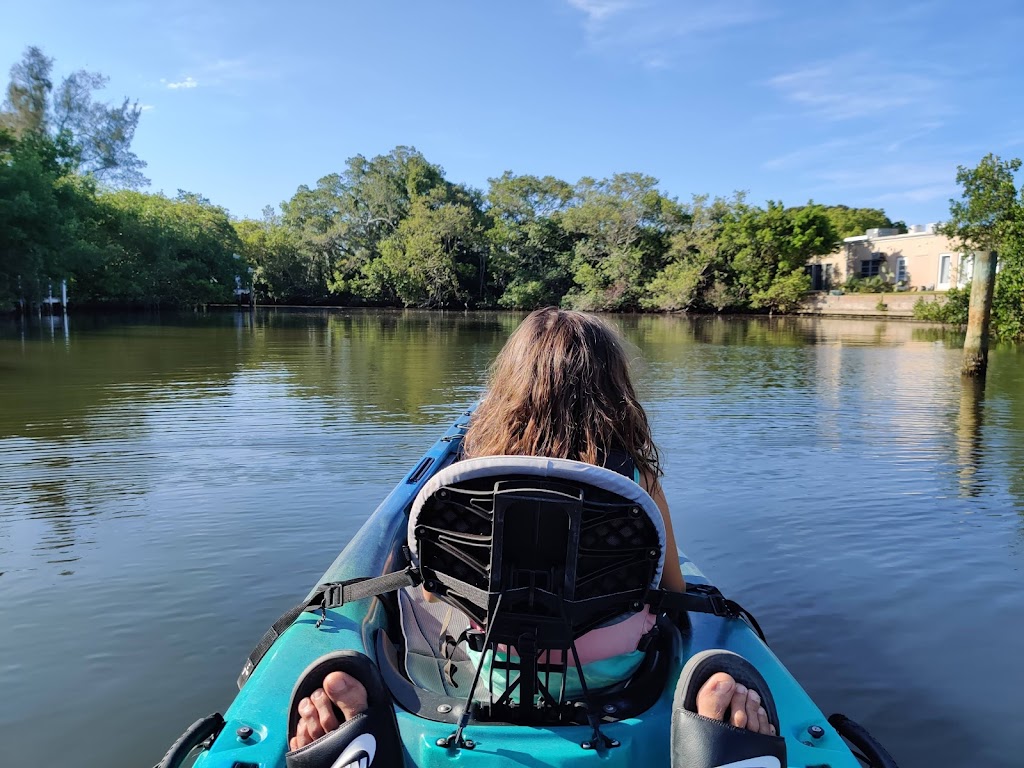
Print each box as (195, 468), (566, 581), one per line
(567, 0), (767, 69)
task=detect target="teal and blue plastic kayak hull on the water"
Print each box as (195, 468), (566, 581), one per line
(162, 412), (890, 768)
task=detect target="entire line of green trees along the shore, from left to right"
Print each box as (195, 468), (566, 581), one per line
(0, 48), (1024, 339)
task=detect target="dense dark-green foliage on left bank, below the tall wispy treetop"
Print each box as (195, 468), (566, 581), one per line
(0, 118), (245, 305)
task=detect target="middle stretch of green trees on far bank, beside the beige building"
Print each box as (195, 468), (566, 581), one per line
(237, 146), (905, 311)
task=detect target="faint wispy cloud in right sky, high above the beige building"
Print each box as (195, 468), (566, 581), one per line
(768, 51), (946, 121)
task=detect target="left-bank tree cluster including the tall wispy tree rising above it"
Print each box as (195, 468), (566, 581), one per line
(0, 47), (242, 306)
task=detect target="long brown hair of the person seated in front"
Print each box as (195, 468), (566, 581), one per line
(463, 307), (662, 478)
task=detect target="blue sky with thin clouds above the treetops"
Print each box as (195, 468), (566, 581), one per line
(0, 0), (1024, 223)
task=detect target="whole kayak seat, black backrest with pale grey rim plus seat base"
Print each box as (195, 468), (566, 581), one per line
(378, 457), (671, 724)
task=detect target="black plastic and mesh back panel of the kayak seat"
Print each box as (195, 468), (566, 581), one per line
(411, 460), (665, 649)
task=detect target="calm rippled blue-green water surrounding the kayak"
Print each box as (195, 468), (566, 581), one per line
(0, 312), (1024, 768)
